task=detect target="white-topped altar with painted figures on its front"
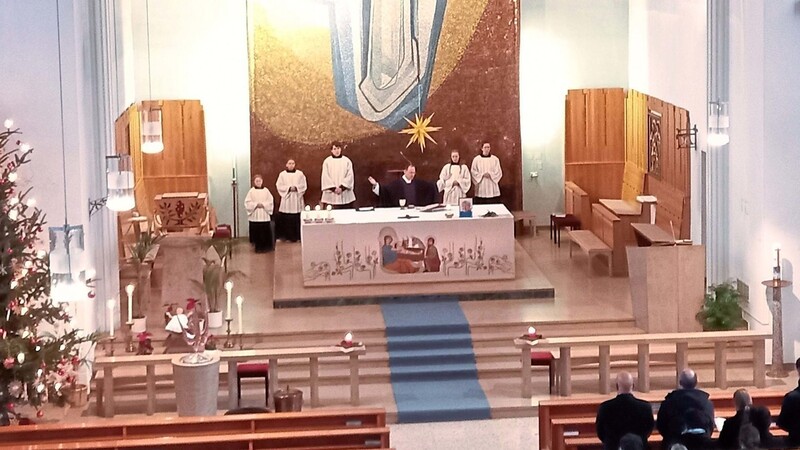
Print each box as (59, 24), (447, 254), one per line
(301, 204), (515, 286)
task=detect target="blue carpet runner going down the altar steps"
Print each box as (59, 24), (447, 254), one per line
(381, 297), (490, 423)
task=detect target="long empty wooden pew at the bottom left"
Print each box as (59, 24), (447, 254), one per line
(0, 408), (389, 449)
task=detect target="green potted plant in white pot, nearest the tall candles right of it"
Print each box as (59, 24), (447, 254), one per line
(192, 239), (244, 328)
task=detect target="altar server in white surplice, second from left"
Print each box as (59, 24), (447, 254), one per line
(275, 159), (308, 242)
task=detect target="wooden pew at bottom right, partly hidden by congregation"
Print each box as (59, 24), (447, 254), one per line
(539, 390), (785, 450)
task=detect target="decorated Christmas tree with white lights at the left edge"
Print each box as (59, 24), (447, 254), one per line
(0, 121), (96, 425)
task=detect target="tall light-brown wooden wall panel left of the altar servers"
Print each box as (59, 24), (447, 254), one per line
(115, 100), (208, 221)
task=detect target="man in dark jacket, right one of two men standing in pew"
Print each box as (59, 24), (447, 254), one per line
(656, 369), (714, 450)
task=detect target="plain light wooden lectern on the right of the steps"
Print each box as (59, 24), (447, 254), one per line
(627, 245), (706, 333)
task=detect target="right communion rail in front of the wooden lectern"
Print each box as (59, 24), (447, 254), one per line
(514, 330), (771, 396)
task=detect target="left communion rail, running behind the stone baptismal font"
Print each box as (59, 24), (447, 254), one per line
(94, 346), (367, 417)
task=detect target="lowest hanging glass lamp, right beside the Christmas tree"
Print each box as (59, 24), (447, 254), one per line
(49, 224), (89, 303)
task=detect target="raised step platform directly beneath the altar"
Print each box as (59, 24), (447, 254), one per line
(272, 242), (555, 309)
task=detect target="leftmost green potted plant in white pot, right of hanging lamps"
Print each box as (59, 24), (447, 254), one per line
(128, 221), (164, 333)
